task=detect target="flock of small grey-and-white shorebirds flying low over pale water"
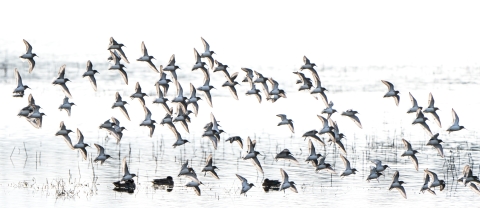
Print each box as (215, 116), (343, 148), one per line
(13, 38), (480, 198)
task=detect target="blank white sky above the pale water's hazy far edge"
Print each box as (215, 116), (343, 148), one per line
(0, 1), (480, 67)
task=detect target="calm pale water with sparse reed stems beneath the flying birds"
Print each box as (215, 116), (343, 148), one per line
(0, 58), (480, 207)
